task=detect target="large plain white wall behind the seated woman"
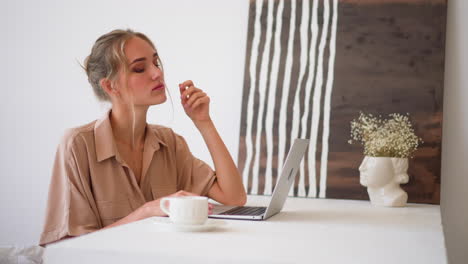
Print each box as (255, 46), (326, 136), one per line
(0, 0), (249, 246)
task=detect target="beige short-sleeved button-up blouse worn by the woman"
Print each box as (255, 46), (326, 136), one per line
(40, 112), (216, 245)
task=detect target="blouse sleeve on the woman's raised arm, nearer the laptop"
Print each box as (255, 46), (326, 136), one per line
(175, 134), (216, 196)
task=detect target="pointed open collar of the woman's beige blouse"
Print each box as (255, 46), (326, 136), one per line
(94, 110), (167, 162)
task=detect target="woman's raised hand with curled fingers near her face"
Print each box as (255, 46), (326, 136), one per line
(179, 80), (211, 123)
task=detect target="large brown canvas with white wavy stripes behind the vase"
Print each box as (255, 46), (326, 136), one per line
(238, 0), (447, 204)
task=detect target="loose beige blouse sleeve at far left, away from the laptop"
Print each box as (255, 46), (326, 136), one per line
(39, 131), (101, 245)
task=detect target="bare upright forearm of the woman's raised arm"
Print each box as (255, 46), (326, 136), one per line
(195, 120), (247, 205)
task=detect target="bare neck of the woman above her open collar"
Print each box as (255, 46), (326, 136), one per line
(110, 105), (148, 149)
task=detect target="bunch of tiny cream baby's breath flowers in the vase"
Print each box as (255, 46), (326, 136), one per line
(348, 112), (423, 158)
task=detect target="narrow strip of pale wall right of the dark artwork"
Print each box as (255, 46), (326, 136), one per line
(441, 0), (468, 264)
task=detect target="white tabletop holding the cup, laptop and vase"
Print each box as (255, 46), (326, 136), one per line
(44, 196), (447, 264)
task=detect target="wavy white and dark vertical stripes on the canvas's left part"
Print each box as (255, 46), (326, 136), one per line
(239, 0), (338, 197)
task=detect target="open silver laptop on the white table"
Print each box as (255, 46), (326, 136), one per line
(209, 139), (309, 220)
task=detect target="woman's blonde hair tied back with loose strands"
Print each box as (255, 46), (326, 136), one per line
(82, 29), (156, 101)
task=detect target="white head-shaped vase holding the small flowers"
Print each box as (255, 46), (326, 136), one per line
(359, 156), (409, 207)
